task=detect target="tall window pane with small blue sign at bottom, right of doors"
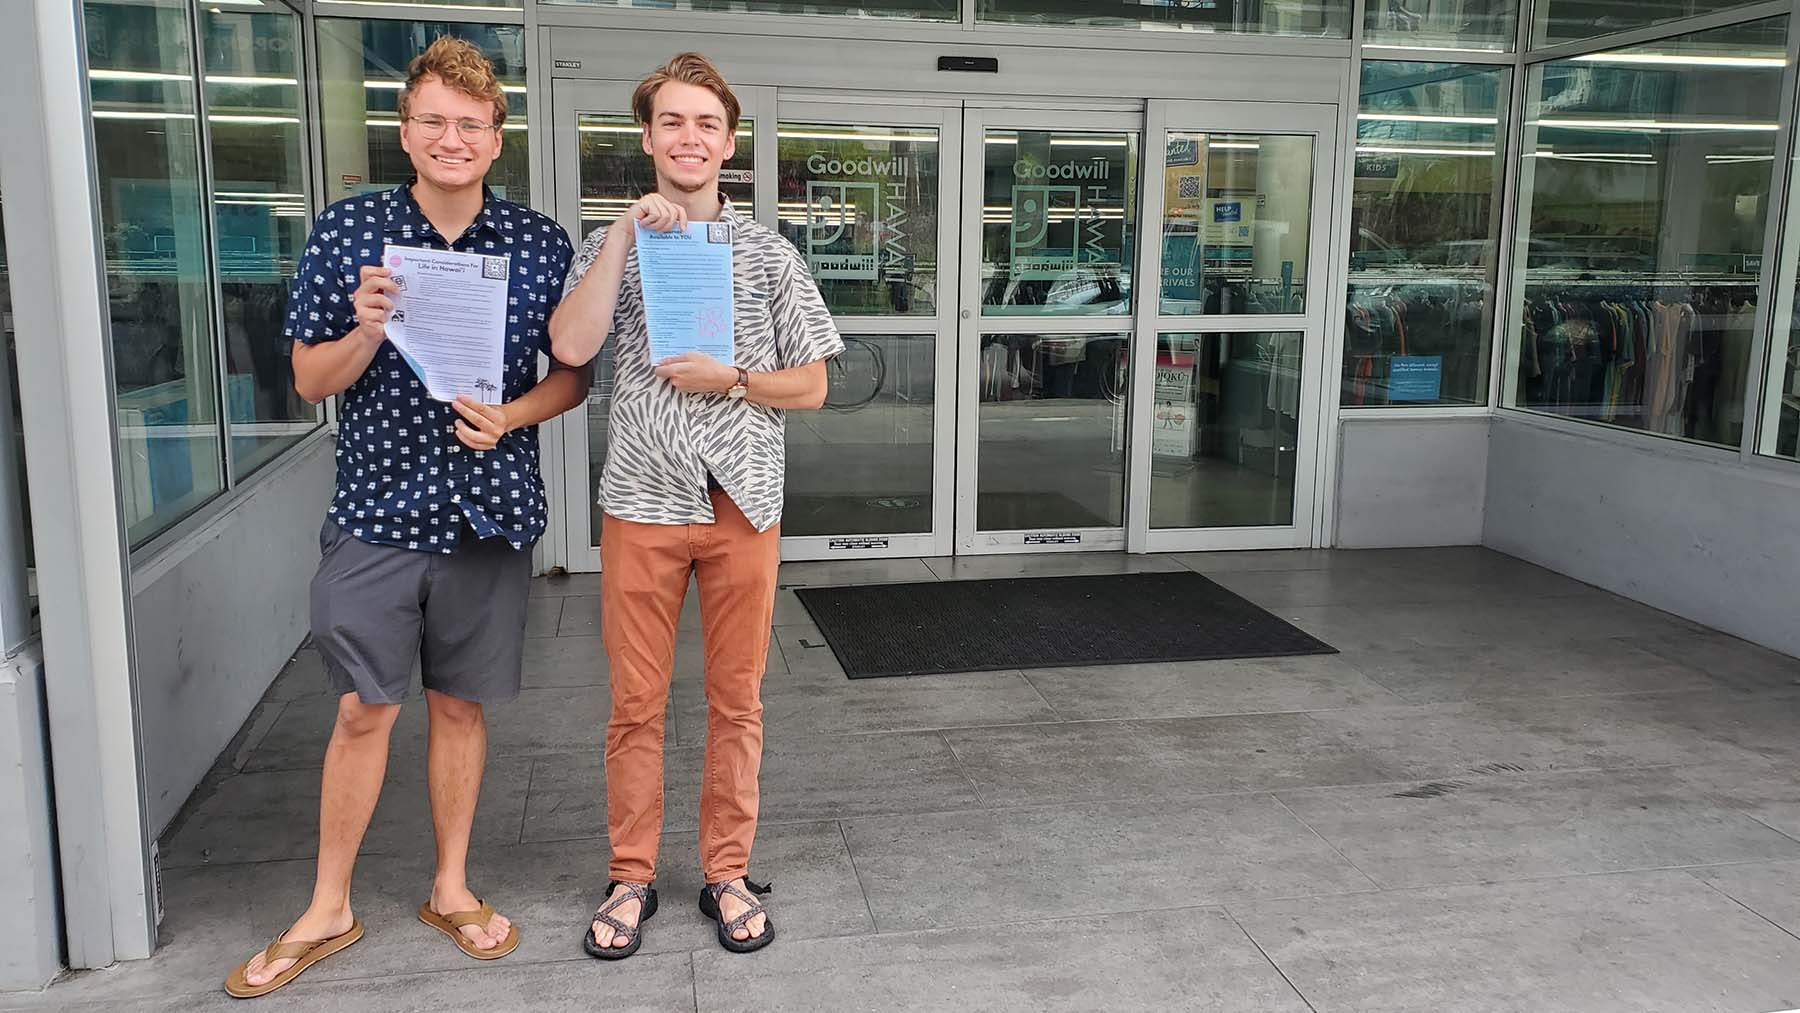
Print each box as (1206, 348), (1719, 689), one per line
(1343, 61), (1512, 407)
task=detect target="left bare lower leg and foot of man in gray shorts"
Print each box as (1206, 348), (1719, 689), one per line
(245, 693), (400, 984)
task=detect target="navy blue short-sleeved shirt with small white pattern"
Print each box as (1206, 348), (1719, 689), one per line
(286, 187), (572, 552)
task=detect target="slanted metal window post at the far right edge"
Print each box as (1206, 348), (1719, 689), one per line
(1739, 6), (1800, 462)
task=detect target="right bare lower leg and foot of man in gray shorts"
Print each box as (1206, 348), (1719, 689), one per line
(425, 689), (513, 950)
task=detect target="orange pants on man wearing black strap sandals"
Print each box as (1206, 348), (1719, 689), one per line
(599, 489), (781, 883)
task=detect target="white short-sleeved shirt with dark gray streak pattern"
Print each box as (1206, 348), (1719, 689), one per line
(563, 202), (844, 531)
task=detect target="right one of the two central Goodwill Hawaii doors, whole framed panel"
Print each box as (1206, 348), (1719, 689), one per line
(956, 108), (1143, 552)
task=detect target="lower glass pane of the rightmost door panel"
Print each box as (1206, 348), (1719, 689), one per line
(1150, 331), (1303, 527)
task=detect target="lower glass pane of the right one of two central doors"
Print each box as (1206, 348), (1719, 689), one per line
(976, 335), (1130, 531)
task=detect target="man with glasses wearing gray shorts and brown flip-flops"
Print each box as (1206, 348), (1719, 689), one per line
(225, 38), (592, 999)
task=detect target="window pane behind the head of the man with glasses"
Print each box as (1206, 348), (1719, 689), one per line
(319, 18), (531, 203)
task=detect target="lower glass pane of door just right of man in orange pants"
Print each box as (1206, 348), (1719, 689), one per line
(781, 333), (938, 536)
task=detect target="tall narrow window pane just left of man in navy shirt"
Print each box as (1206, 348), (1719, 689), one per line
(202, 9), (319, 480)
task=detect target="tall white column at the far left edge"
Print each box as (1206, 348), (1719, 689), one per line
(0, 0), (155, 968)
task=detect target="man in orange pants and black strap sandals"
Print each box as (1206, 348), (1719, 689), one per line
(551, 54), (844, 959)
